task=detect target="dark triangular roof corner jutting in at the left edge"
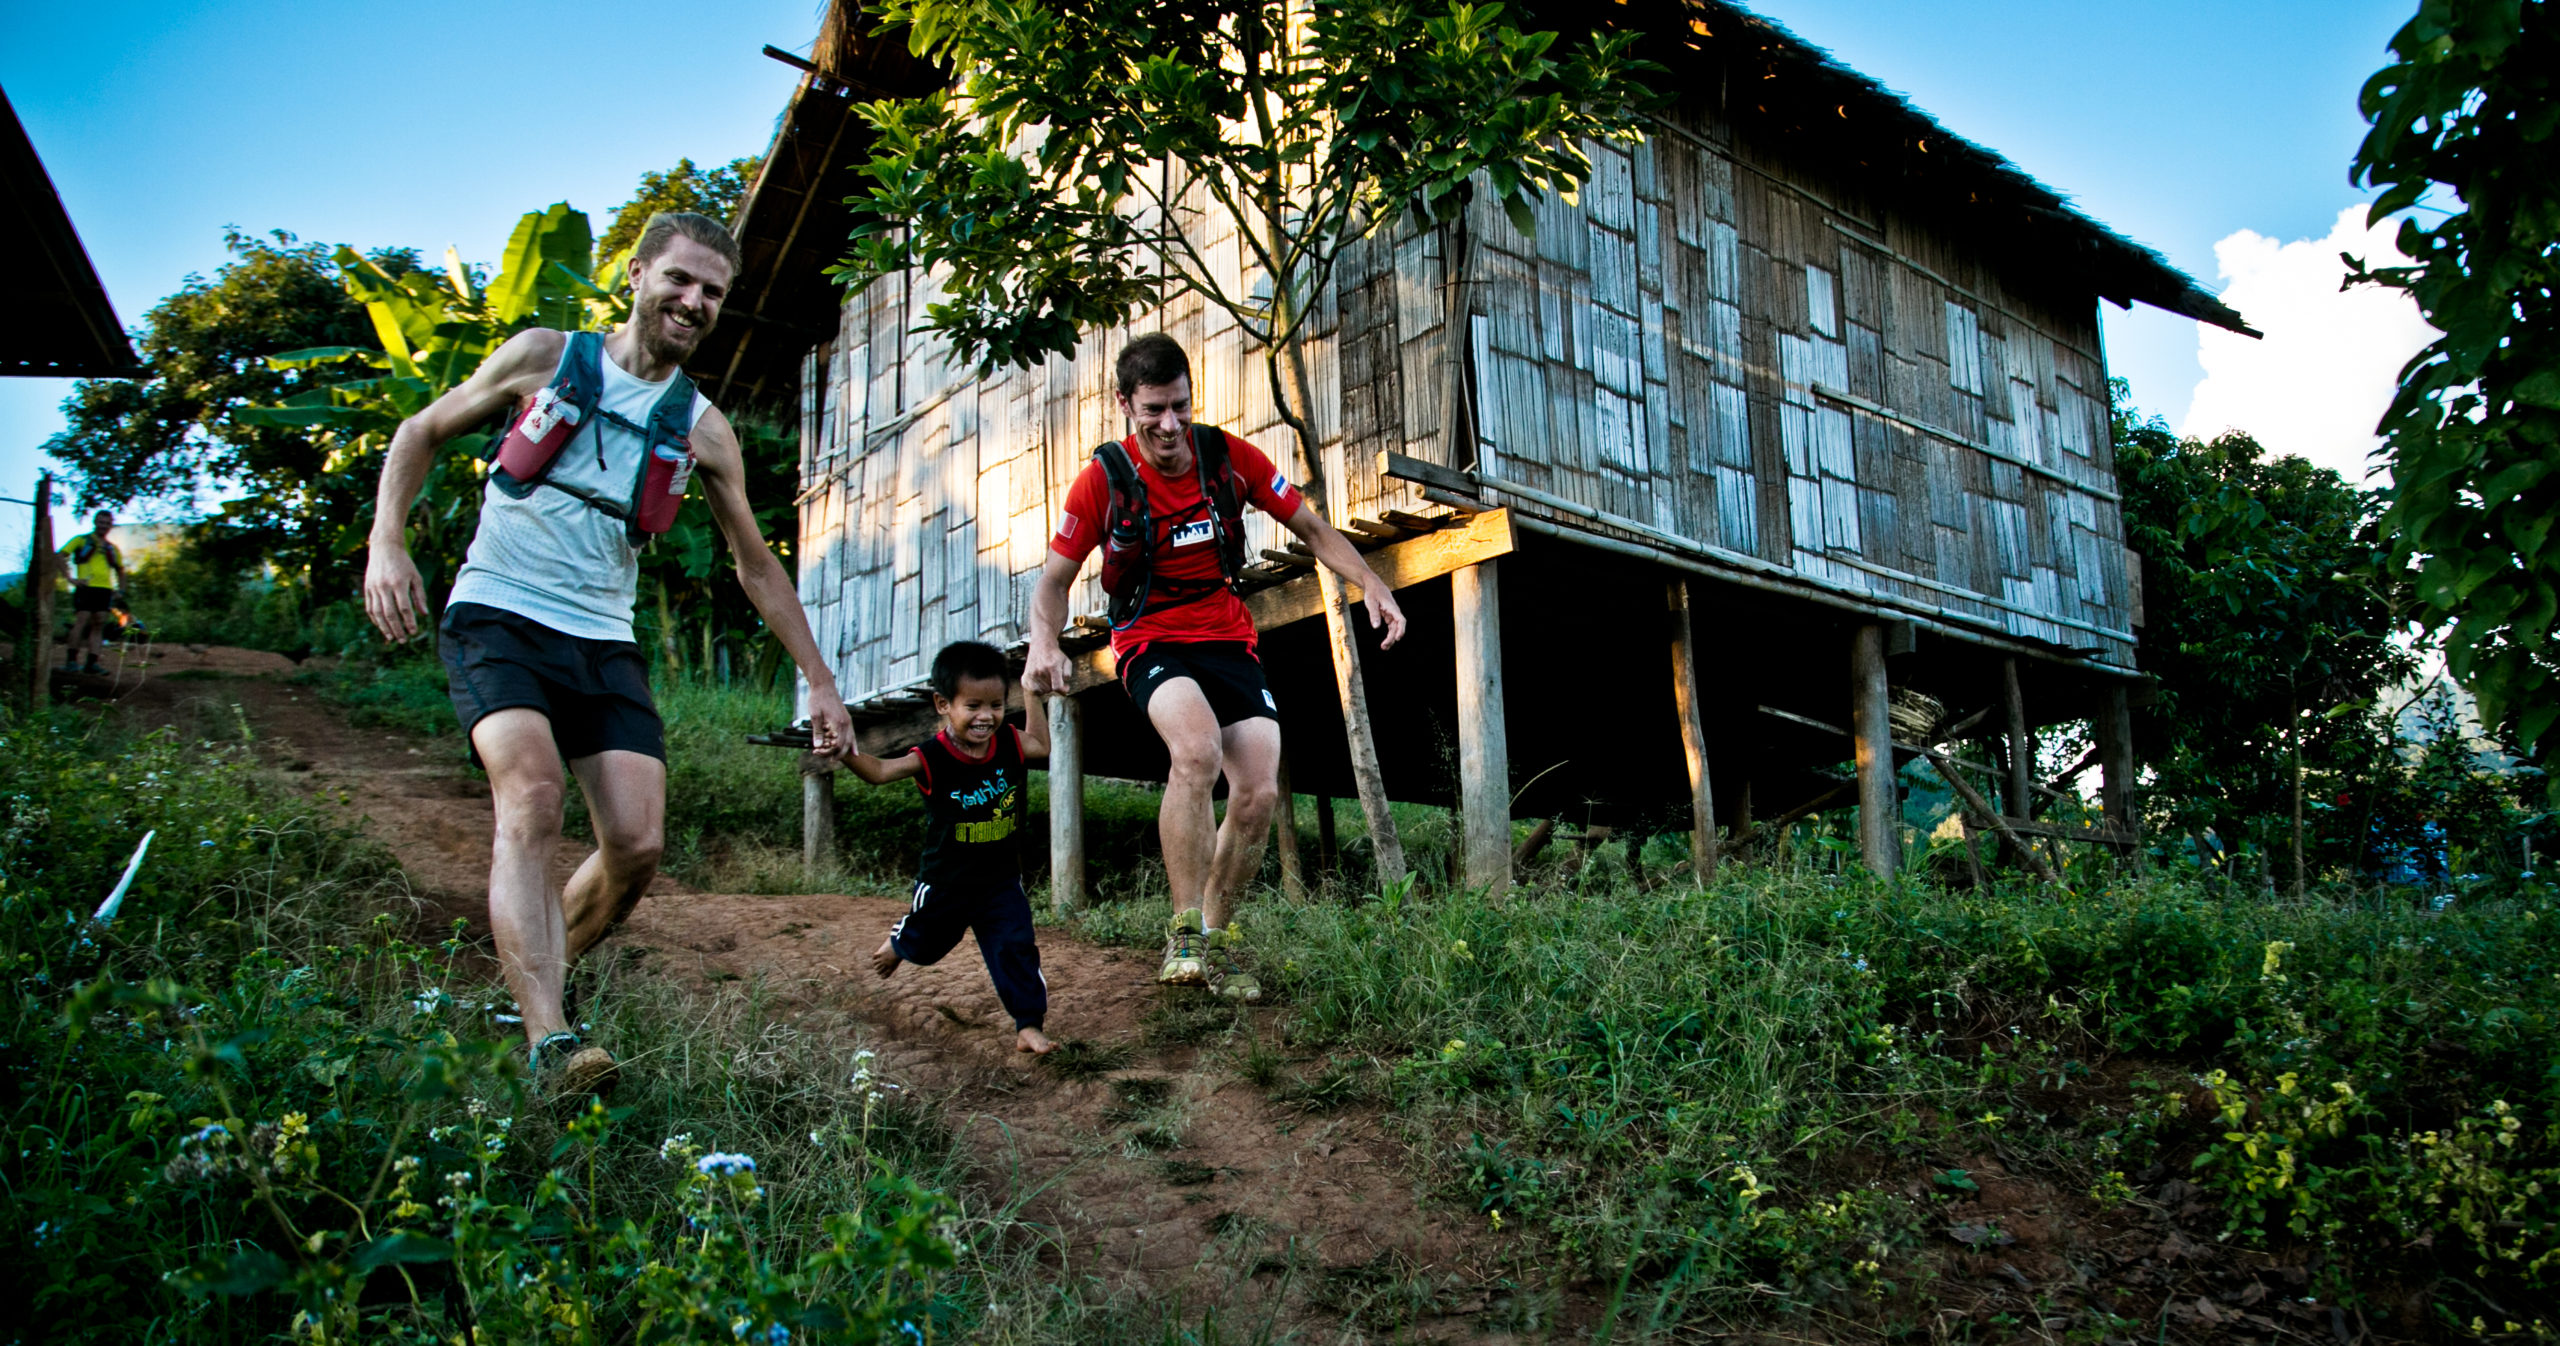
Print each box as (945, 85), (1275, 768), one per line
(0, 92), (141, 379)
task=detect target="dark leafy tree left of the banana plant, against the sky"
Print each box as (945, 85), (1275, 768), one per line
(44, 230), (417, 583)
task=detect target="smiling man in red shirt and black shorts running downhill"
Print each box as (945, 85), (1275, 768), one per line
(1021, 333), (1405, 1001)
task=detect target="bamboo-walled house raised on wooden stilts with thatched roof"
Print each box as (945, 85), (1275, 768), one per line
(696, 0), (2248, 883)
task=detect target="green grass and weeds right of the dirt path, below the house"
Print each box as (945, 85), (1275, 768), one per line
(1208, 865), (2560, 1331)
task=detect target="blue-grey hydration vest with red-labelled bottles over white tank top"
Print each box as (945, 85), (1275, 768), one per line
(489, 333), (694, 545)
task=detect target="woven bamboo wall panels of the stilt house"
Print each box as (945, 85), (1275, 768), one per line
(799, 113), (2132, 696)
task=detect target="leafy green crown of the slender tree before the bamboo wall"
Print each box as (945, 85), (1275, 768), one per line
(837, 0), (1651, 435)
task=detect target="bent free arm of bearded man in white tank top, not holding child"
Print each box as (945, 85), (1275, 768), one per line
(364, 328), (568, 640)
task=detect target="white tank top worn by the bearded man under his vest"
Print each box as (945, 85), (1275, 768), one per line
(448, 343), (709, 640)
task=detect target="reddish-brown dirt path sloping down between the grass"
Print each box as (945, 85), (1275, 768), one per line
(120, 650), (1508, 1341)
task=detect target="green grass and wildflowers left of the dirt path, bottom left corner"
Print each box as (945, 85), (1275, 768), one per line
(0, 711), (1280, 1343)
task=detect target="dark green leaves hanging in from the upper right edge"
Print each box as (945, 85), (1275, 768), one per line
(2348, 0), (2560, 777)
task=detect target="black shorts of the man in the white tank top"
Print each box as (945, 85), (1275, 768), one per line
(435, 604), (666, 763)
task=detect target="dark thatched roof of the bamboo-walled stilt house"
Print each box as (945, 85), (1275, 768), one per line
(694, 0), (2258, 404)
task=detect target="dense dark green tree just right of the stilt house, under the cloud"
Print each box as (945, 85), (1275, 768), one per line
(2115, 381), (2414, 880)
